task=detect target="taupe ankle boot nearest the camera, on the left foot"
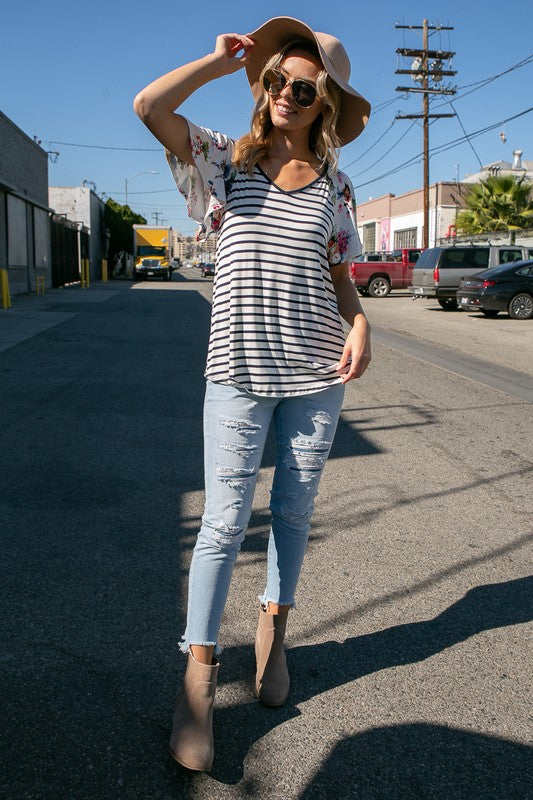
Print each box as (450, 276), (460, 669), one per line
(169, 653), (218, 772)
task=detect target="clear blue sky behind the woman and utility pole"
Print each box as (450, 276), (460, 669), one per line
(0, 0), (533, 233)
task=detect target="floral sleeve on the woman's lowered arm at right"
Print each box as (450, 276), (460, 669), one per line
(328, 172), (362, 264)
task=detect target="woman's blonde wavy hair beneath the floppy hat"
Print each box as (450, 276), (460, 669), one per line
(232, 39), (341, 175)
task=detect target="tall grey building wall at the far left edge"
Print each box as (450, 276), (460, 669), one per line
(0, 112), (51, 294)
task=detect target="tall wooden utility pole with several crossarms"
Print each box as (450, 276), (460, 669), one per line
(395, 19), (457, 247)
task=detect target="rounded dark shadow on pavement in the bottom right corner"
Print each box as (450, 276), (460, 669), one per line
(299, 724), (533, 800)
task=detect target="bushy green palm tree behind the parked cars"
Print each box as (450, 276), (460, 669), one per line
(456, 175), (533, 241)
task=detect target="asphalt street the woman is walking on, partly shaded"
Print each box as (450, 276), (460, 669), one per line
(0, 270), (533, 800)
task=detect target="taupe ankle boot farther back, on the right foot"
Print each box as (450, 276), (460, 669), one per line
(255, 607), (290, 706)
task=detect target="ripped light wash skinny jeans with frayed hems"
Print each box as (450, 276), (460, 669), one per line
(181, 381), (344, 652)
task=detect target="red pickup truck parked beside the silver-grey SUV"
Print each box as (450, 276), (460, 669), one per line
(350, 247), (424, 297)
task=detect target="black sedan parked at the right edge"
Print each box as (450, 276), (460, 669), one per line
(457, 260), (533, 319)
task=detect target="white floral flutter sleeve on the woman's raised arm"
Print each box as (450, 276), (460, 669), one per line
(165, 120), (235, 239)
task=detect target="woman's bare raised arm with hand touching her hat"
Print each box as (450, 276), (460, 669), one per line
(133, 33), (254, 164)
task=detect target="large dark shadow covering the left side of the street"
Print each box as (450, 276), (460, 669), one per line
(0, 288), (210, 800)
